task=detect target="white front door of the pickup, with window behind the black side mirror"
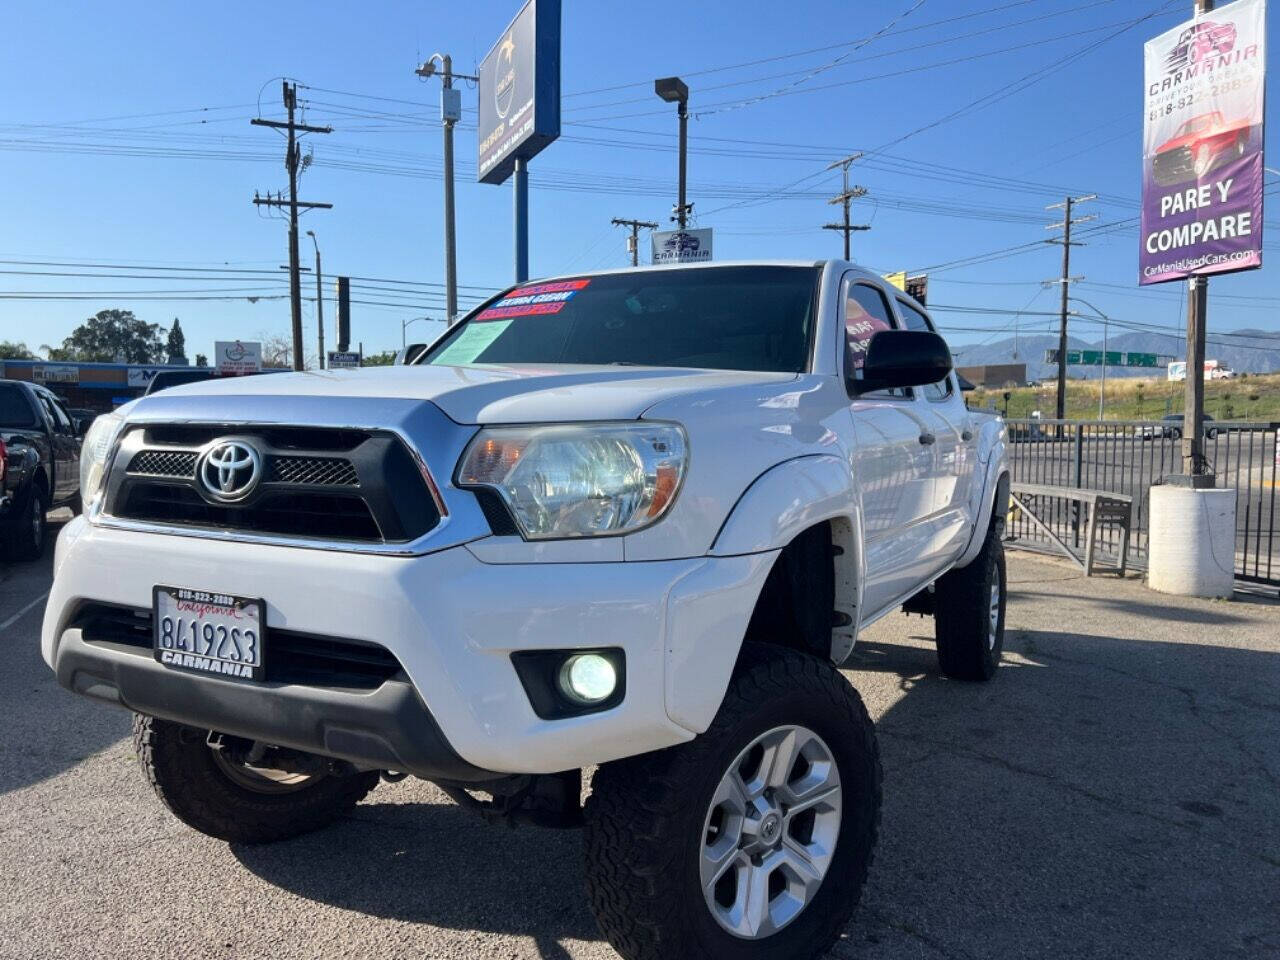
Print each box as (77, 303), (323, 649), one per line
(844, 275), (933, 616)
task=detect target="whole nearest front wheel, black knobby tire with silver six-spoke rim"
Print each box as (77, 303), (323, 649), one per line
(585, 644), (881, 960)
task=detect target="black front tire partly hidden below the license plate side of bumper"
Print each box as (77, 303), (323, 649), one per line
(133, 714), (379, 844)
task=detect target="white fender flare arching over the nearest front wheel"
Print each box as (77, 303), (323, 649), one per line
(709, 453), (865, 663)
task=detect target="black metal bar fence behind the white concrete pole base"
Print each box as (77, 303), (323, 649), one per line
(1006, 420), (1280, 586)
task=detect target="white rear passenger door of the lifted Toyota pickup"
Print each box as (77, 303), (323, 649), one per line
(896, 297), (978, 568)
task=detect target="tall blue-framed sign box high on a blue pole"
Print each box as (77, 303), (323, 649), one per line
(476, 0), (561, 183)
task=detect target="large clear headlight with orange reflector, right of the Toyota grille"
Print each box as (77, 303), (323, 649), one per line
(458, 422), (689, 540)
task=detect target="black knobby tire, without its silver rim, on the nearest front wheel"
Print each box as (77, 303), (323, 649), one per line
(585, 644), (881, 960)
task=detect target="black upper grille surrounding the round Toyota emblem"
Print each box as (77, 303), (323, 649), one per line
(104, 424), (440, 544)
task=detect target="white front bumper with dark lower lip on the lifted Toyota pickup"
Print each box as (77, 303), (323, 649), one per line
(42, 517), (776, 781)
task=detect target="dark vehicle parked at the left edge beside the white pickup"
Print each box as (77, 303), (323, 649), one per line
(0, 380), (87, 559)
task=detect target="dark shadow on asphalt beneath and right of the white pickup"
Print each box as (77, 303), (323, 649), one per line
(234, 622), (1280, 960)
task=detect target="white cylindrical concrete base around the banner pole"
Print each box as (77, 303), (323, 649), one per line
(1147, 486), (1235, 596)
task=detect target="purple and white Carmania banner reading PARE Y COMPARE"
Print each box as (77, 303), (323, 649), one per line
(1138, 0), (1266, 284)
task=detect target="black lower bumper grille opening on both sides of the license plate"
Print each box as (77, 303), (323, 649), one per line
(70, 603), (402, 690)
